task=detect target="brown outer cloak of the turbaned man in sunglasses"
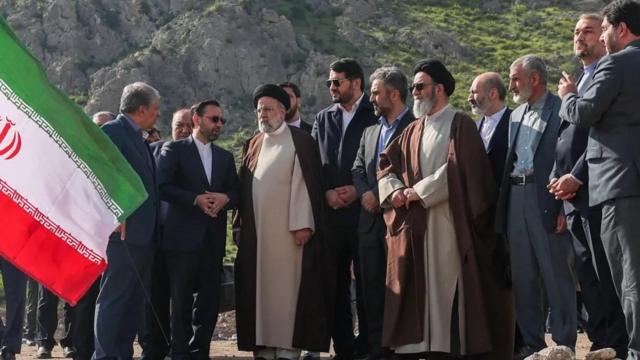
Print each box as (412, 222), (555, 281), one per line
(378, 113), (515, 359)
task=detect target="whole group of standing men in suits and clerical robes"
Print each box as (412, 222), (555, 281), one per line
(1, 0), (640, 360)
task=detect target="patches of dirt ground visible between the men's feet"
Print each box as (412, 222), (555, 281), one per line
(12, 311), (591, 360)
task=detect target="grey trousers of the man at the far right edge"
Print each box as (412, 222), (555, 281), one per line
(600, 196), (640, 359)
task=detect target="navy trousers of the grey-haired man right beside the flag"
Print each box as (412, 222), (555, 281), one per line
(93, 241), (154, 359)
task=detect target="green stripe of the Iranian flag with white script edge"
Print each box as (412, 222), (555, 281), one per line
(0, 16), (148, 221)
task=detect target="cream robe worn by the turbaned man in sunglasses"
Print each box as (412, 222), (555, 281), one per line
(378, 105), (466, 354)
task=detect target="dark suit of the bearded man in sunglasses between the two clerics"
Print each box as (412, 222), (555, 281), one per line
(311, 94), (378, 358)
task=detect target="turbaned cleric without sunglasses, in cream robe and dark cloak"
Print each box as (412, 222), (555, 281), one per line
(235, 84), (333, 359)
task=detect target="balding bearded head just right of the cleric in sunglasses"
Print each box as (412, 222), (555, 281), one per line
(467, 72), (507, 116)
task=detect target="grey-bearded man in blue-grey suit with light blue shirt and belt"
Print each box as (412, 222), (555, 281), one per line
(496, 55), (576, 358)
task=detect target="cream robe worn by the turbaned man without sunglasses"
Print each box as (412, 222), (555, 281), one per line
(252, 123), (315, 349)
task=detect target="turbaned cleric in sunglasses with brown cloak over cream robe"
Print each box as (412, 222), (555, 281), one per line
(378, 60), (513, 359)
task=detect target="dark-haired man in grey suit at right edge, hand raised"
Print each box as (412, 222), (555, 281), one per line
(558, 0), (640, 359)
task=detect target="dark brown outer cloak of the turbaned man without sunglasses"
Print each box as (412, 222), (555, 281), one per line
(234, 127), (333, 351)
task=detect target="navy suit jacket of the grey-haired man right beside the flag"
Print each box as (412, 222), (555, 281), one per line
(102, 114), (160, 245)
